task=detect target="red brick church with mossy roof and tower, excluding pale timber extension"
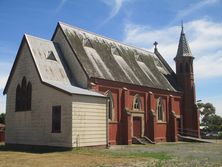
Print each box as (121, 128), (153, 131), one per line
(52, 23), (200, 144)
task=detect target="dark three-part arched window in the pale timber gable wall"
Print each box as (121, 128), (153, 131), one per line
(15, 77), (32, 111)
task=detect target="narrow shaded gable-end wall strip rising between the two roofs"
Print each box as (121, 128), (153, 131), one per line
(53, 28), (88, 88)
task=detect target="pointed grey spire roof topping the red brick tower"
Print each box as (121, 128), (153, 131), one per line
(176, 22), (192, 57)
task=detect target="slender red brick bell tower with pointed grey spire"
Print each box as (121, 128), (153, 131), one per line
(174, 23), (200, 137)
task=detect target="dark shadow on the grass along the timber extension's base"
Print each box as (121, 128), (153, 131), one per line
(0, 144), (72, 154)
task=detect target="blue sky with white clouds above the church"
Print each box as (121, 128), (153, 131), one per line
(0, 0), (222, 116)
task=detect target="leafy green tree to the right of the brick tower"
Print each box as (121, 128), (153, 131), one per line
(197, 103), (222, 132)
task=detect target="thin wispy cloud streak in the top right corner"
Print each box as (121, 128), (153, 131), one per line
(170, 0), (221, 25)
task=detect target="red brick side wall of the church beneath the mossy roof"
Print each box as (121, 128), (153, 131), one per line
(90, 79), (182, 144)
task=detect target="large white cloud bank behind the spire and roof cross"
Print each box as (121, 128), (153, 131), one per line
(124, 19), (222, 79)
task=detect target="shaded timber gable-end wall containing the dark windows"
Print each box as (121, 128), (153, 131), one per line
(6, 43), (72, 147)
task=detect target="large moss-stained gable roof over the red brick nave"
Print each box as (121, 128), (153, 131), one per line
(55, 22), (180, 91)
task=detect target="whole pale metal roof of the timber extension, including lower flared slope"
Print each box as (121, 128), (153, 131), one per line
(3, 35), (104, 97)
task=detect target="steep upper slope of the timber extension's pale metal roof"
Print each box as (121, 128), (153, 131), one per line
(26, 35), (70, 84)
